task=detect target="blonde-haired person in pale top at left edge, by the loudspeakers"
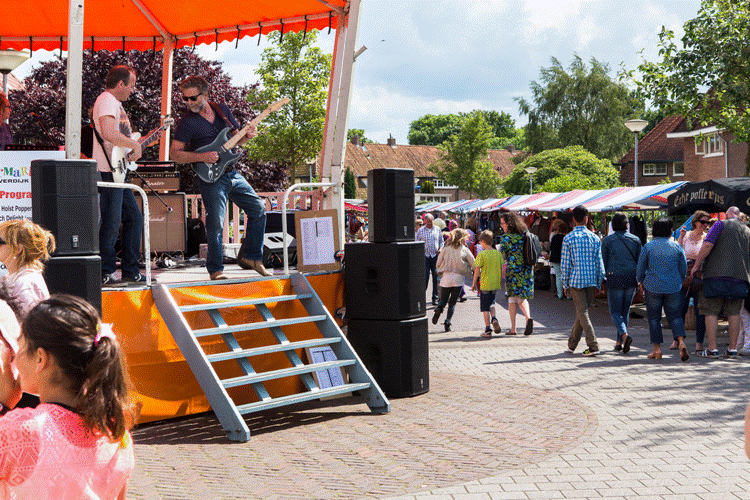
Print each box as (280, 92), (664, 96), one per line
(0, 219), (55, 320)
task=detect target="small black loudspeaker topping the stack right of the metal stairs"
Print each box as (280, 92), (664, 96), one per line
(367, 168), (414, 243)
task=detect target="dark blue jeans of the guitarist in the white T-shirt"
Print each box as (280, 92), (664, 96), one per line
(98, 172), (143, 278)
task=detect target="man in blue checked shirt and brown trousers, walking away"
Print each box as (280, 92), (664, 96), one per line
(560, 205), (604, 356)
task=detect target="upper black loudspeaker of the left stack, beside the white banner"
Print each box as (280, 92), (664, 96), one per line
(31, 160), (101, 256)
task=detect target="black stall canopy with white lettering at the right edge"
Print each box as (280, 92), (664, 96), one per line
(667, 177), (750, 215)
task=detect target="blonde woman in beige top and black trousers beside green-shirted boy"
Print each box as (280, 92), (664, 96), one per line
(432, 228), (474, 332)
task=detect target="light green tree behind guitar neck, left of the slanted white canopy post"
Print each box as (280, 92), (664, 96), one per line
(248, 31), (331, 178)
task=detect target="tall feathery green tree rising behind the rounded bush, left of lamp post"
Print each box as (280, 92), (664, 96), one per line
(518, 55), (643, 160)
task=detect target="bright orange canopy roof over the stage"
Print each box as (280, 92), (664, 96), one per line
(0, 0), (348, 51)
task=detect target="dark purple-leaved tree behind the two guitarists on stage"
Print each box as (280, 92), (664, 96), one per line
(10, 48), (286, 192)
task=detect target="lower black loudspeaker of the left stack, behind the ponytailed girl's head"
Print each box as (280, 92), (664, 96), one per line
(44, 255), (102, 314)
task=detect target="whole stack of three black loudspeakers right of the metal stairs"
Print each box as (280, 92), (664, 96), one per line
(344, 169), (430, 398)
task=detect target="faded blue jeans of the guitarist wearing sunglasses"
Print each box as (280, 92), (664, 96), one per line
(198, 170), (266, 273)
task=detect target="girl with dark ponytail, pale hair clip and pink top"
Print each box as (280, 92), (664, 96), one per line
(0, 295), (135, 500)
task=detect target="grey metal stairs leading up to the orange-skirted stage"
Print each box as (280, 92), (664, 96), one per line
(152, 273), (390, 441)
